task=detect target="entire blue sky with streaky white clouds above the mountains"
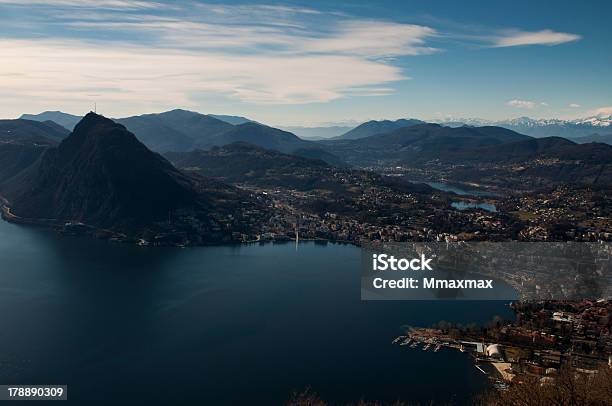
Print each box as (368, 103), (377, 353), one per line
(0, 0), (612, 126)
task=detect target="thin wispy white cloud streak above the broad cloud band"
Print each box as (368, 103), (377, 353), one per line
(59, 17), (436, 58)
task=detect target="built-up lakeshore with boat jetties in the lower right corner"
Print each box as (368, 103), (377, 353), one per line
(393, 299), (612, 390)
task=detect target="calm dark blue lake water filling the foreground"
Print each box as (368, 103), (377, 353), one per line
(0, 221), (511, 405)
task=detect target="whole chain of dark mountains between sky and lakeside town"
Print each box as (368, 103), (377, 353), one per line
(0, 110), (612, 244)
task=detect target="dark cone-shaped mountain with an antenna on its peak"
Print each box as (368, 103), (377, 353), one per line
(4, 113), (202, 230)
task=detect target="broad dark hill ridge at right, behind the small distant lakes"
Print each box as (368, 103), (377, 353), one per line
(321, 123), (612, 190)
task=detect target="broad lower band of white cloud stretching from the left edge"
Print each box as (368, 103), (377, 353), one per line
(0, 40), (405, 113)
